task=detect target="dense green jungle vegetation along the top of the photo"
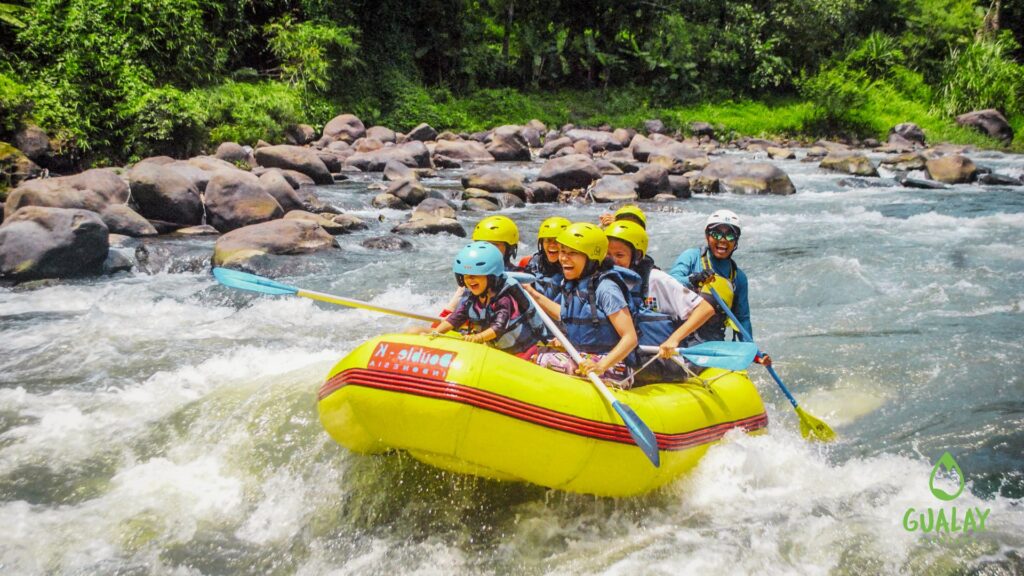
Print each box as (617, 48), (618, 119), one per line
(0, 0), (1024, 164)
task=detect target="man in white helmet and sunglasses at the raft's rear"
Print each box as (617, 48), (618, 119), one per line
(669, 210), (771, 366)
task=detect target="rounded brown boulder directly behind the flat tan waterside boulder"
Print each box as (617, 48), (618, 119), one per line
(206, 170), (285, 232)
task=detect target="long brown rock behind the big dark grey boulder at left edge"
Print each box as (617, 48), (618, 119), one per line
(4, 168), (129, 217)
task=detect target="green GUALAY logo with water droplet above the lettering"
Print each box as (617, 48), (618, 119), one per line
(903, 452), (992, 538)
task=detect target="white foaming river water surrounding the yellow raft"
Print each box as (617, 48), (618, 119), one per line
(0, 153), (1024, 575)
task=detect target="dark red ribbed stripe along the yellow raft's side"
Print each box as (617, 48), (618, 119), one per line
(317, 368), (768, 450)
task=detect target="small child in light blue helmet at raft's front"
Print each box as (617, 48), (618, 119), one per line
(409, 242), (542, 358)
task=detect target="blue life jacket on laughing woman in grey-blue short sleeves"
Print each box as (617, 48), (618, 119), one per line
(560, 266), (640, 354)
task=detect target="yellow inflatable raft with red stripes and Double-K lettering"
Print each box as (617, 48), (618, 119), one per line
(318, 334), (768, 496)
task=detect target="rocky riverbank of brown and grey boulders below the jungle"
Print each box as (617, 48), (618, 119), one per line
(0, 109), (1024, 282)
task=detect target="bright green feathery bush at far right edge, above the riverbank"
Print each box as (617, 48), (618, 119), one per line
(938, 39), (1024, 116)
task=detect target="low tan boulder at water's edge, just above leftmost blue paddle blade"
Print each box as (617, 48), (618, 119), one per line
(213, 219), (338, 268)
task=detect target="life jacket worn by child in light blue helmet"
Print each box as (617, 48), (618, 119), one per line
(463, 278), (547, 354)
